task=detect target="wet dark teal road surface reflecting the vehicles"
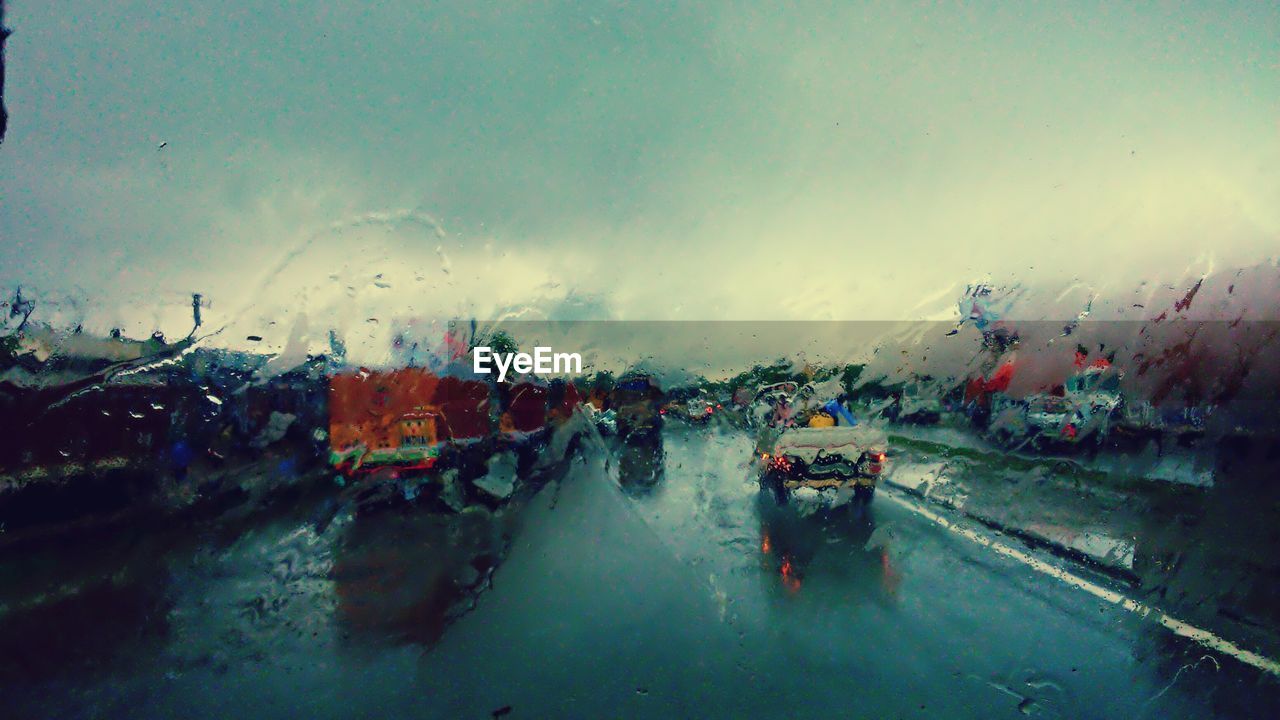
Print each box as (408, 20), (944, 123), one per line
(0, 428), (1280, 717)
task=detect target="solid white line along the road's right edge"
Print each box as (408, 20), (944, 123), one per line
(884, 493), (1280, 675)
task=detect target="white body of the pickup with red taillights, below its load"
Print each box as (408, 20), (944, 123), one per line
(756, 425), (888, 503)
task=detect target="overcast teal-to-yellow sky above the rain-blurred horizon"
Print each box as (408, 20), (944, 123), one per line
(0, 0), (1280, 343)
